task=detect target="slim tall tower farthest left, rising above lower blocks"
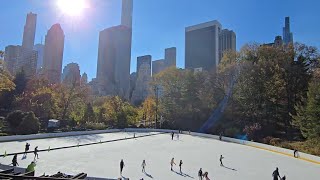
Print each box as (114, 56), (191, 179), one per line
(22, 12), (37, 50)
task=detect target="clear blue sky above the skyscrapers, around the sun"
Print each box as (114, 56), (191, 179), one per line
(0, 0), (320, 79)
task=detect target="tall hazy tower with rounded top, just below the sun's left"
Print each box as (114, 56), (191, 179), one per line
(42, 24), (64, 84)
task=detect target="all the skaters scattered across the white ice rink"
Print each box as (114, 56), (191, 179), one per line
(4, 130), (292, 180)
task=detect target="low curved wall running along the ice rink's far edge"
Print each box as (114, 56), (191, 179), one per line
(0, 128), (320, 165)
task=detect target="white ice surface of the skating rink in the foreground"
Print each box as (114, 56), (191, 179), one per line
(0, 132), (320, 180)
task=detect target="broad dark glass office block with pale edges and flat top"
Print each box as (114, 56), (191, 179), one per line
(185, 20), (222, 71)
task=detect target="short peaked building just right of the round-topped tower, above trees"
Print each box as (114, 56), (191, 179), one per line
(62, 63), (81, 85)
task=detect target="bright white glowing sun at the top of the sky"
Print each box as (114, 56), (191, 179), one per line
(57, 0), (88, 16)
